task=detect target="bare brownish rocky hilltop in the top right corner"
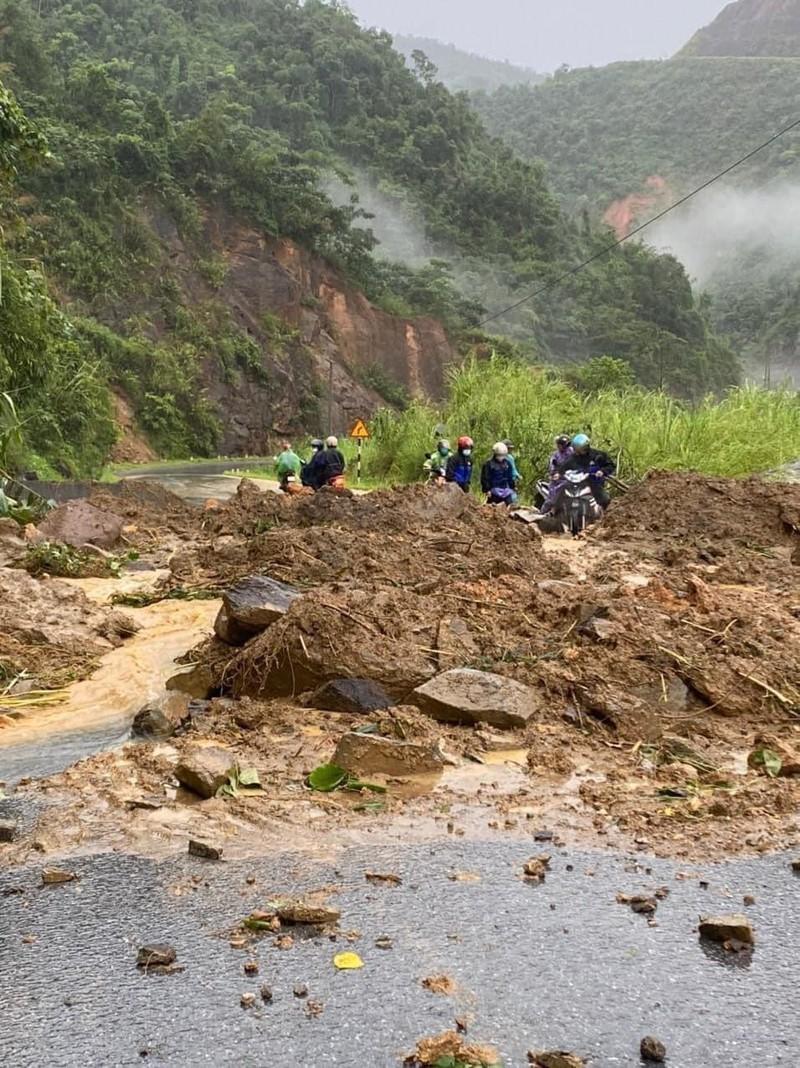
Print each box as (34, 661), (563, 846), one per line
(680, 0), (800, 56)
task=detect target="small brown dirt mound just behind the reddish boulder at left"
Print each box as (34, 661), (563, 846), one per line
(89, 478), (202, 547)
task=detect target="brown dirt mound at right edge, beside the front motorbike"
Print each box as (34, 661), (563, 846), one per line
(598, 471), (800, 550)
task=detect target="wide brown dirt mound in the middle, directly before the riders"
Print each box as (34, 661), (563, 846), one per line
(200, 486), (561, 592)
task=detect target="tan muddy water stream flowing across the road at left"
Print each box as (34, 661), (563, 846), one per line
(0, 571), (219, 783)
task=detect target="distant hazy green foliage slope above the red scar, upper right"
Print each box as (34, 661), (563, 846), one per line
(474, 59), (800, 206)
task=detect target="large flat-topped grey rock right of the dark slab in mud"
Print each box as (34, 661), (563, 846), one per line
(414, 668), (543, 727)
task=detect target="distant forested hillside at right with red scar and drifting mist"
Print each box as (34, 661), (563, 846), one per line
(475, 58), (800, 378)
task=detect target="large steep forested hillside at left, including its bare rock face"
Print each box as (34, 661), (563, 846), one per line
(0, 0), (737, 471)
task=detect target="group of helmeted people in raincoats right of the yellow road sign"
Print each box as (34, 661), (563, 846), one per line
(425, 434), (616, 515)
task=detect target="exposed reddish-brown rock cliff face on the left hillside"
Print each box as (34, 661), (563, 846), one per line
(126, 213), (457, 455)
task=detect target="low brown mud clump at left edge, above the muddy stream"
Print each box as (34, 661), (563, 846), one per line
(0, 568), (138, 688)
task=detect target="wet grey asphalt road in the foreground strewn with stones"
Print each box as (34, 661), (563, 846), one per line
(0, 839), (800, 1068)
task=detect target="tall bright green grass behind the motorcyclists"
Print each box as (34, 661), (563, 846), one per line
(366, 357), (800, 485)
